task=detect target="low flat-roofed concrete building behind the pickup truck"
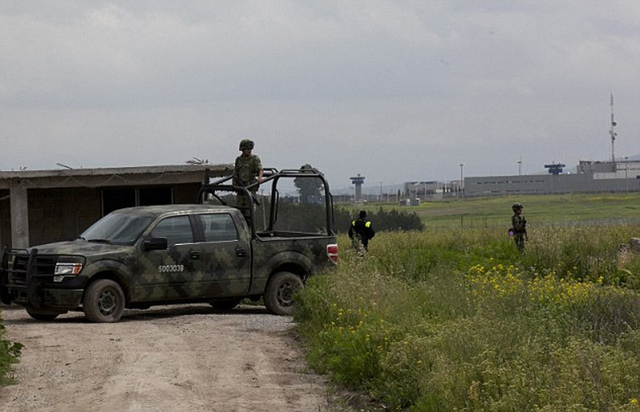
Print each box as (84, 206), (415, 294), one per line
(0, 164), (233, 248)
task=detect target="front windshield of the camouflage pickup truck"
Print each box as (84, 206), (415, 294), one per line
(80, 213), (153, 245)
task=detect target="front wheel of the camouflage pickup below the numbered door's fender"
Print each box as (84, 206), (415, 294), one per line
(82, 279), (125, 323)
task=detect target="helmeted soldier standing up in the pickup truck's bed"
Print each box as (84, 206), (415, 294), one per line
(233, 139), (262, 221)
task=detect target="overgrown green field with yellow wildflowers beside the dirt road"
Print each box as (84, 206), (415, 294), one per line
(295, 224), (640, 411)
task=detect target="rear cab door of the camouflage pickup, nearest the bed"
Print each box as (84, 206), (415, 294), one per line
(198, 213), (251, 298)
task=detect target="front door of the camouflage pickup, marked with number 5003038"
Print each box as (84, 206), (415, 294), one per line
(136, 215), (202, 301)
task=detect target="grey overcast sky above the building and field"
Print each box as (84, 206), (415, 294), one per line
(0, 0), (640, 192)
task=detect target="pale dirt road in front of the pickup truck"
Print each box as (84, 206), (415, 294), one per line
(0, 305), (330, 412)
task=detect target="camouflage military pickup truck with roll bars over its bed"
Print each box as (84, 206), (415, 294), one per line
(0, 170), (338, 322)
